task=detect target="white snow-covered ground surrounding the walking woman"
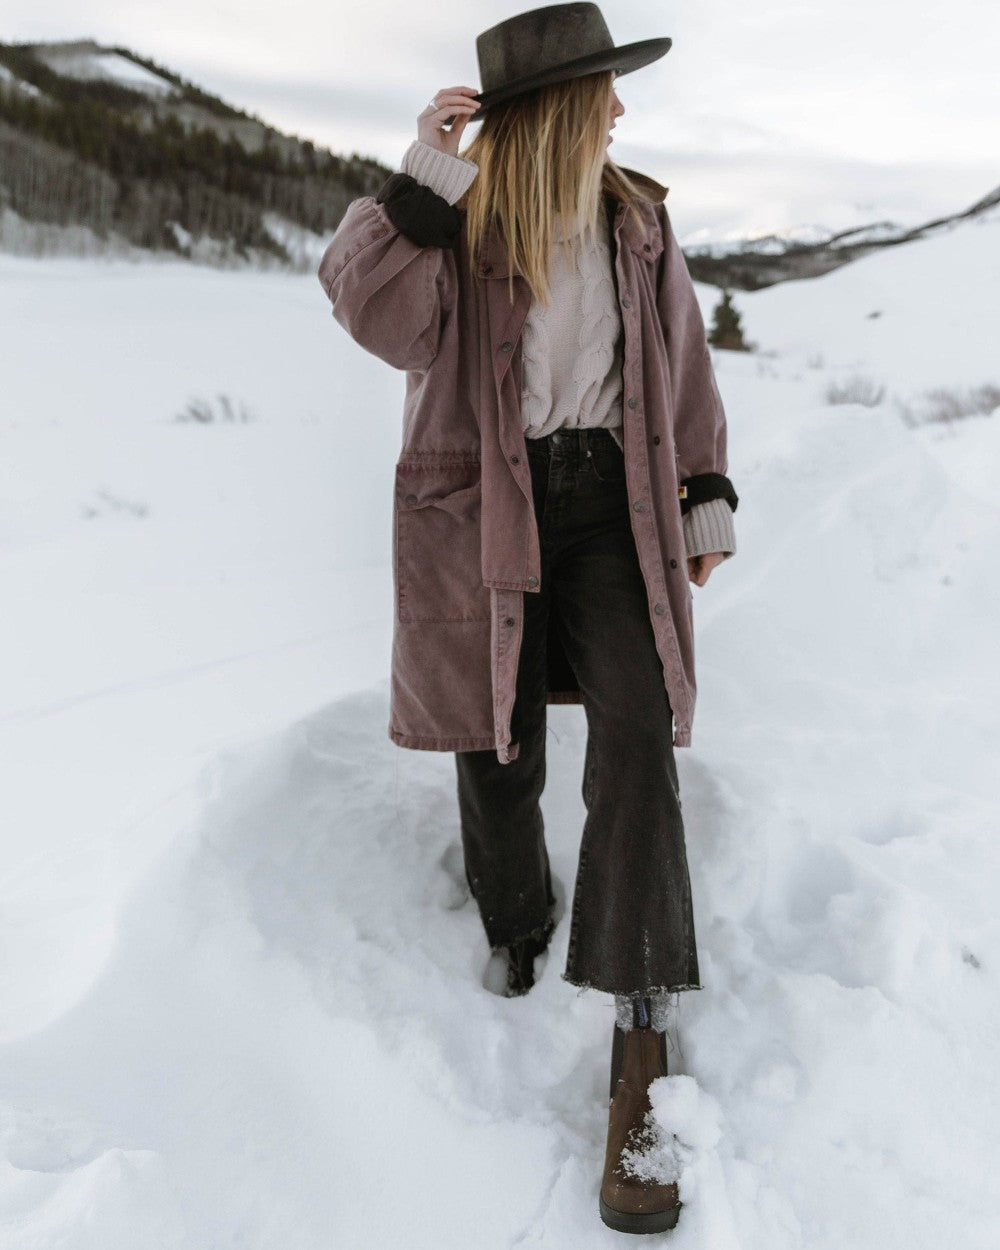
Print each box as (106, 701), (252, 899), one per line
(0, 210), (1000, 1250)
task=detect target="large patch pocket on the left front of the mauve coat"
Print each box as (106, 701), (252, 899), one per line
(395, 456), (490, 621)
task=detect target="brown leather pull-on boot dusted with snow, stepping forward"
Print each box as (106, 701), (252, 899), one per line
(600, 1025), (681, 1233)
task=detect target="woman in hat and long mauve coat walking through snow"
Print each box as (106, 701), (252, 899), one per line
(320, 4), (736, 1233)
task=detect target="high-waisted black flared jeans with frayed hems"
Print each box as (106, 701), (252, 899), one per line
(455, 429), (699, 994)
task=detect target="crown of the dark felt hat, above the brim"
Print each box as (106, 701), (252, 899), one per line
(476, 4), (615, 95)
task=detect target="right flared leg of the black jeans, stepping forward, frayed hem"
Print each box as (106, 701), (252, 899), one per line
(553, 460), (699, 994)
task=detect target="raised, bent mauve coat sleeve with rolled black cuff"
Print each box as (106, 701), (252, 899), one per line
(319, 174), (459, 370)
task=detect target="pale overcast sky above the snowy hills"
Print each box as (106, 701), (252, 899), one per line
(0, 0), (1000, 241)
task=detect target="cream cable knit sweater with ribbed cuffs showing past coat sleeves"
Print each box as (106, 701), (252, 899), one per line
(401, 139), (736, 556)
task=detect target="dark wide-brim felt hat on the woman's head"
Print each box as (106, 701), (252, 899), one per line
(469, 4), (671, 121)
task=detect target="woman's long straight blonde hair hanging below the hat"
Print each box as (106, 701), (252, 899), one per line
(459, 70), (641, 304)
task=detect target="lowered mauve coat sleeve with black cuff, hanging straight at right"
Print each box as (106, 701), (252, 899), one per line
(658, 205), (739, 515)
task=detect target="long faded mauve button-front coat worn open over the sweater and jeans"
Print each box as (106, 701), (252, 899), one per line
(320, 171), (726, 763)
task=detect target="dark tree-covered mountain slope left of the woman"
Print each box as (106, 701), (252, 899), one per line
(0, 40), (390, 268)
